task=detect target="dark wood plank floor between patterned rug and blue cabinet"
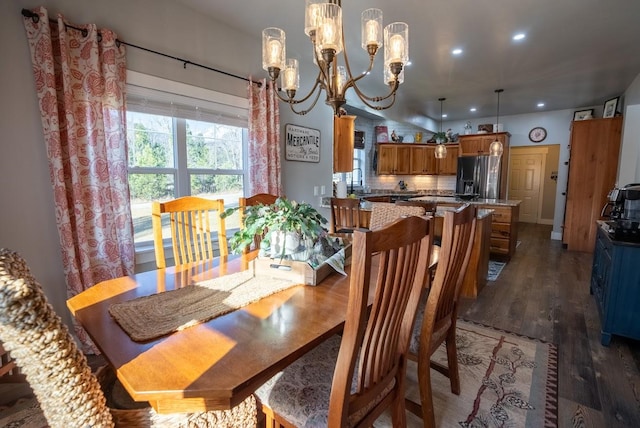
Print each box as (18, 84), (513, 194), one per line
(460, 223), (640, 428)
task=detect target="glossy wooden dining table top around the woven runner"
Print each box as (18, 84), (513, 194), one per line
(67, 252), (364, 413)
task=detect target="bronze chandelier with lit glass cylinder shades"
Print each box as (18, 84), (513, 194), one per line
(262, 0), (409, 116)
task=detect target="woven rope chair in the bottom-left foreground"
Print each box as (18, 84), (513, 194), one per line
(0, 248), (257, 428)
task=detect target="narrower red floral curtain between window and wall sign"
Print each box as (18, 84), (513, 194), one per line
(247, 79), (282, 195)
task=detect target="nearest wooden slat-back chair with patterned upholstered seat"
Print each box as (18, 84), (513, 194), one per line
(256, 217), (431, 428)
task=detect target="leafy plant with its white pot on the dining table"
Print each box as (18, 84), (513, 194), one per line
(222, 198), (327, 261)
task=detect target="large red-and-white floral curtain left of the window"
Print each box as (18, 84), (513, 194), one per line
(24, 7), (135, 352)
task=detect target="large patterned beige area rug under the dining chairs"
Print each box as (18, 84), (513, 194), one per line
(398, 321), (558, 428)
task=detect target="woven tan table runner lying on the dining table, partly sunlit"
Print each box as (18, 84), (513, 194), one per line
(109, 270), (299, 342)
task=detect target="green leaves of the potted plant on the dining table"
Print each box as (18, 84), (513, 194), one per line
(221, 198), (327, 253)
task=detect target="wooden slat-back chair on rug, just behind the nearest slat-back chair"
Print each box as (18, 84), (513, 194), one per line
(406, 204), (476, 427)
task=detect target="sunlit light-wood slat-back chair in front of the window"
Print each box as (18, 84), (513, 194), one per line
(151, 196), (229, 269)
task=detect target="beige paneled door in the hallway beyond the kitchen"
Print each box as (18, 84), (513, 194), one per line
(509, 153), (543, 223)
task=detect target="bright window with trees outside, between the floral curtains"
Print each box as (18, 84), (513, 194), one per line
(127, 73), (248, 250)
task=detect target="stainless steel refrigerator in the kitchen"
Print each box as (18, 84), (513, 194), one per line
(456, 155), (502, 199)
